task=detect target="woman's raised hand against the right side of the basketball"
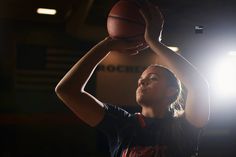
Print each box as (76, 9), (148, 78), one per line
(137, 0), (164, 43)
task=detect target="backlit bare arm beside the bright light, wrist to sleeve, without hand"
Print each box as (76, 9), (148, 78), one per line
(149, 39), (210, 127)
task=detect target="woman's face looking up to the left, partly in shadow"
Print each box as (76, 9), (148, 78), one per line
(136, 66), (168, 106)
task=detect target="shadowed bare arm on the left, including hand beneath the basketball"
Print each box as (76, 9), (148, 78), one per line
(55, 38), (140, 126)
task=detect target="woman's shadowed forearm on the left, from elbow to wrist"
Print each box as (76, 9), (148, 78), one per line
(56, 39), (109, 92)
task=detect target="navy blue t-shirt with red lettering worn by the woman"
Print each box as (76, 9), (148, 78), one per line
(97, 104), (200, 157)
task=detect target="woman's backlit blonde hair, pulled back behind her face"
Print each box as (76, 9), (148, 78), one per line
(150, 64), (184, 117)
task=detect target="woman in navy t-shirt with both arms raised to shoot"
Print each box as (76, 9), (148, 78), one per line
(56, 1), (209, 157)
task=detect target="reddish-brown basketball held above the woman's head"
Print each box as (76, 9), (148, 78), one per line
(107, 0), (146, 48)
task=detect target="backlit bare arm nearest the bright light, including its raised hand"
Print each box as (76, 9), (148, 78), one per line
(141, 2), (210, 127)
